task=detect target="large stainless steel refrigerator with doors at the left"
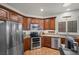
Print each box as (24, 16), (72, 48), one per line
(0, 21), (23, 55)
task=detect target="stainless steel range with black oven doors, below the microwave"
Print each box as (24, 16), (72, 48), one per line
(30, 32), (41, 49)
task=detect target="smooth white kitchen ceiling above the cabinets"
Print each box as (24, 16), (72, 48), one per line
(0, 3), (79, 17)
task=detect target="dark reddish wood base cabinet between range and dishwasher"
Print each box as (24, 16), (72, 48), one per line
(41, 36), (51, 48)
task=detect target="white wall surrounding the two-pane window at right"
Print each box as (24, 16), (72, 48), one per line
(54, 10), (79, 35)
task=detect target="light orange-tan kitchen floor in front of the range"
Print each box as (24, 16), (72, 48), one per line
(24, 47), (60, 55)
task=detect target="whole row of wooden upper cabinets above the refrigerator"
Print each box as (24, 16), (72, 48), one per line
(0, 5), (23, 23)
